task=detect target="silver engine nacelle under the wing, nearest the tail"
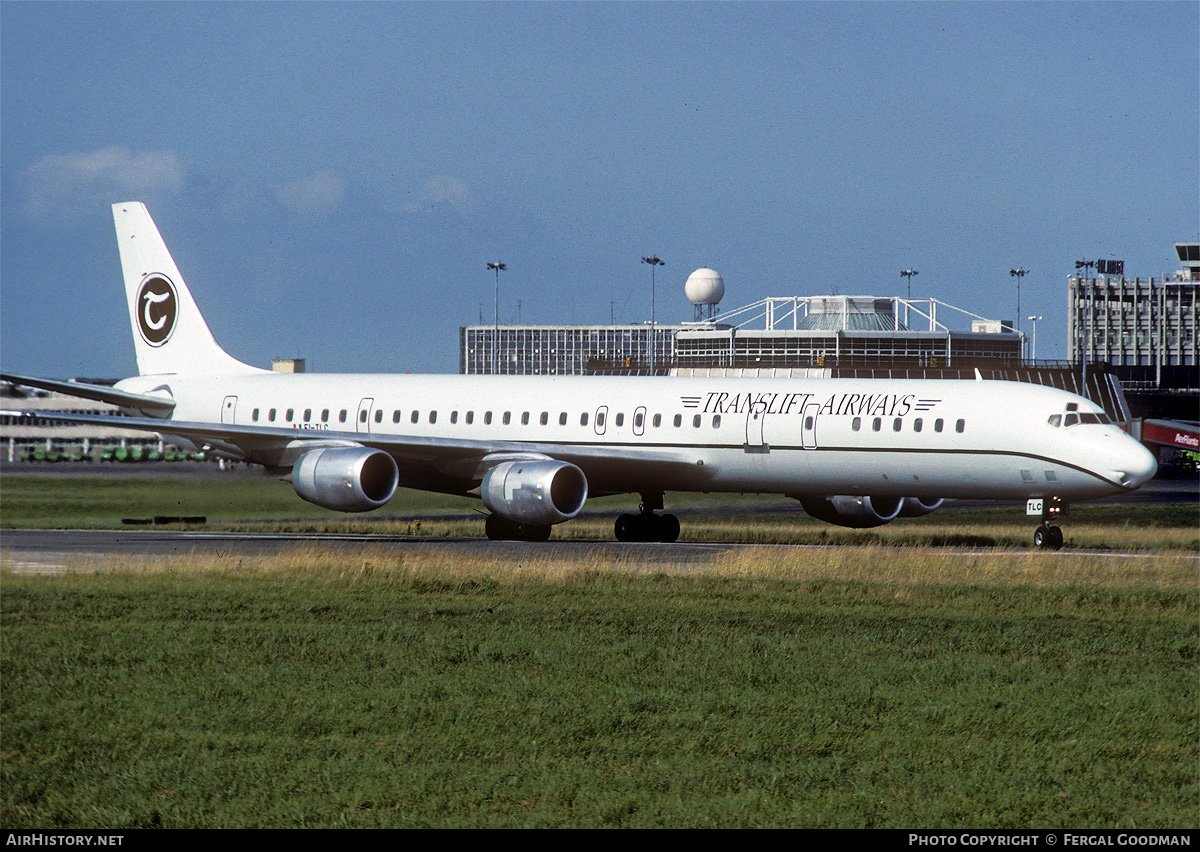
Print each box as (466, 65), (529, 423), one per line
(292, 446), (400, 511)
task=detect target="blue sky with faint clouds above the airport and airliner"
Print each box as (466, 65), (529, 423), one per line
(0, 1), (1200, 377)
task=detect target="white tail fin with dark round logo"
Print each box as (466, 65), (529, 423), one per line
(113, 202), (266, 376)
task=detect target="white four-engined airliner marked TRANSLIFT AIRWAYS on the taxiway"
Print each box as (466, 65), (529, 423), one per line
(4, 202), (1156, 547)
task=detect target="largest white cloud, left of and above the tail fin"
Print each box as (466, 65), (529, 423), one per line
(17, 146), (184, 218)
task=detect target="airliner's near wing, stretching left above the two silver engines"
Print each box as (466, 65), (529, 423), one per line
(0, 408), (712, 493)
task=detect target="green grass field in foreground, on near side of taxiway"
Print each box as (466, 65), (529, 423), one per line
(0, 546), (1200, 828)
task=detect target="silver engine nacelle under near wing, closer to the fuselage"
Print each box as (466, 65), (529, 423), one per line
(480, 458), (588, 526)
